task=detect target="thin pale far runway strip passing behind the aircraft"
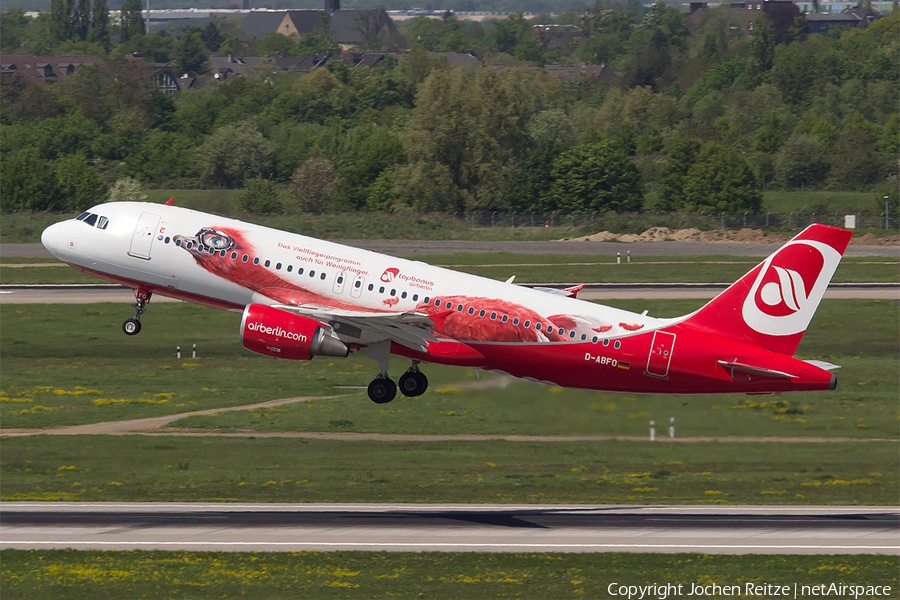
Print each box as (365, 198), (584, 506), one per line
(0, 283), (900, 304)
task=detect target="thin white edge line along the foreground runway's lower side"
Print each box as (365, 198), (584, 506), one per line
(0, 540), (900, 551)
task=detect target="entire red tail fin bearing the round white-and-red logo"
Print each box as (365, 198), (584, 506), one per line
(685, 225), (853, 355)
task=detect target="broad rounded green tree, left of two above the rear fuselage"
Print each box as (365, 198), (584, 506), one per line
(550, 142), (644, 212)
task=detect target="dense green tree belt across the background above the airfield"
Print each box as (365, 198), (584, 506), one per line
(0, 0), (900, 213)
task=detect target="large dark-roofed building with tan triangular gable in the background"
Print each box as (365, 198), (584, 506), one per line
(241, 0), (407, 50)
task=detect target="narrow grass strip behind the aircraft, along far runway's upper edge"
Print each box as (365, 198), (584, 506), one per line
(0, 252), (900, 284)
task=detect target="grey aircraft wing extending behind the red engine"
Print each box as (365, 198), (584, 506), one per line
(273, 304), (441, 352)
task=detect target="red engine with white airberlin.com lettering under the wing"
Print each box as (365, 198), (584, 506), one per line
(241, 304), (350, 360)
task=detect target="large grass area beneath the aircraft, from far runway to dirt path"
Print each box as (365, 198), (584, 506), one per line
(0, 300), (900, 438)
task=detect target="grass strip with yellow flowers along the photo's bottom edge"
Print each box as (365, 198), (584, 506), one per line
(0, 550), (900, 600)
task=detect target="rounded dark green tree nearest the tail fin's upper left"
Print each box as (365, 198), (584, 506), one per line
(674, 142), (762, 213)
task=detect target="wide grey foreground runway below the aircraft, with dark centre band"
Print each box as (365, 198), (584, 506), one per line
(0, 502), (900, 556)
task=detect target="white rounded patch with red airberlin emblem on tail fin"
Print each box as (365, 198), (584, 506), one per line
(742, 240), (841, 336)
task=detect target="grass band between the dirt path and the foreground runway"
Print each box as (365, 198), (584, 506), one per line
(0, 436), (900, 506)
